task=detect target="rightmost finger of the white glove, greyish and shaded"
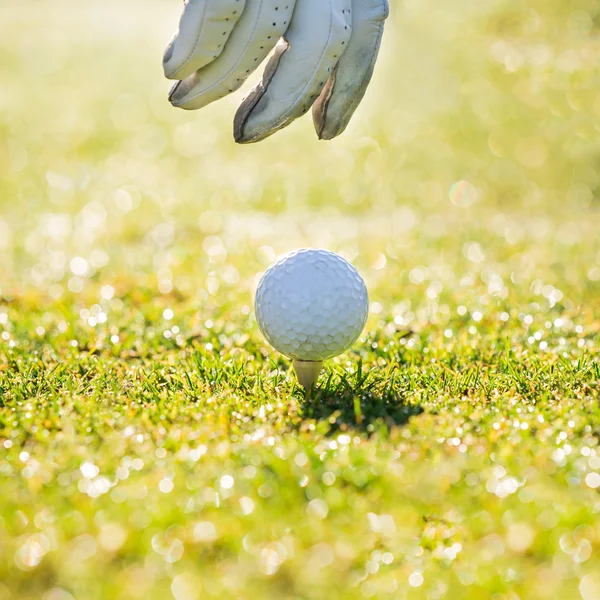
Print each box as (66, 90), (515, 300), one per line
(313, 0), (389, 140)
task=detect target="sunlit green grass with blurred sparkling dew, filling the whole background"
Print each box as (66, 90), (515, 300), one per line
(0, 0), (600, 600)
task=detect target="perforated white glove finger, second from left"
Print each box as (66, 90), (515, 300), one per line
(169, 0), (296, 110)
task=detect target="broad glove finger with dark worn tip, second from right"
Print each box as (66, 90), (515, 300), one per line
(234, 0), (352, 143)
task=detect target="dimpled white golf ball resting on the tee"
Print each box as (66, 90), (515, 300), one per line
(255, 249), (369, 361)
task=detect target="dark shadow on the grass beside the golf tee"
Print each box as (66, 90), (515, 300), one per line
(299, 364), (423, 433)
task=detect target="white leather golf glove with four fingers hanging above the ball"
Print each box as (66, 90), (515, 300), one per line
(163, 0), (388, 143)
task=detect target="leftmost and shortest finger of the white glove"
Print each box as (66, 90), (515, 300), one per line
(163, 0), (246, 79)
